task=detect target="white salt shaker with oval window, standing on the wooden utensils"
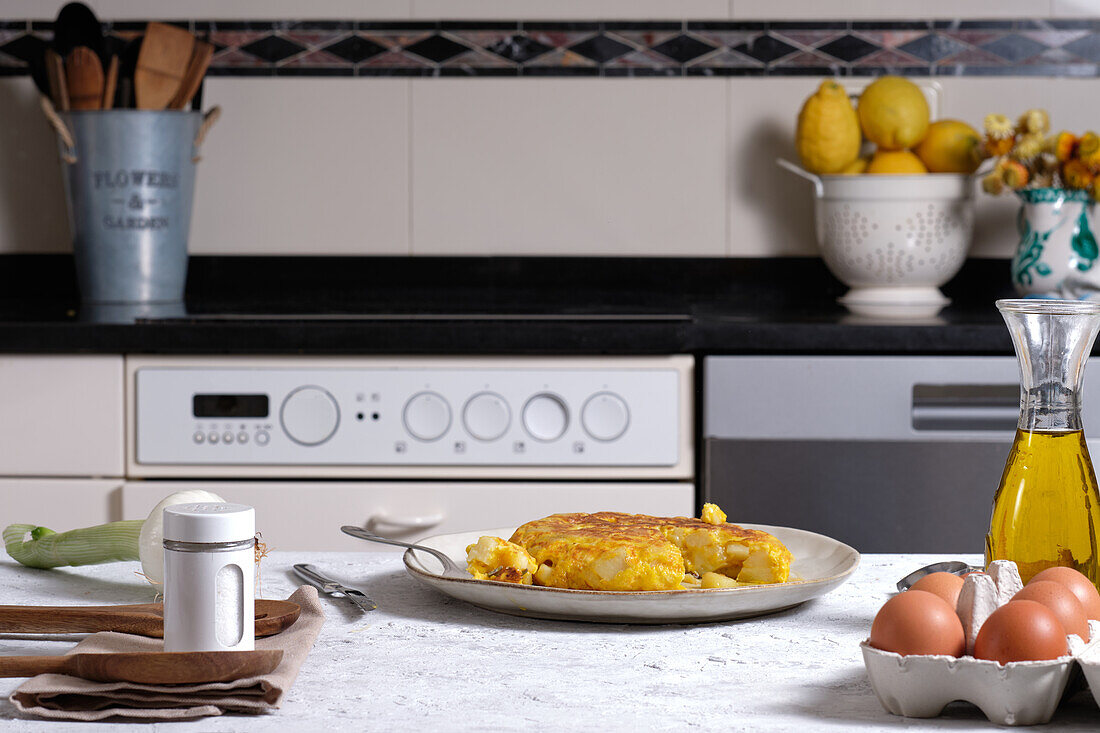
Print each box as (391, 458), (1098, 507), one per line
(164, 502), (256, 652)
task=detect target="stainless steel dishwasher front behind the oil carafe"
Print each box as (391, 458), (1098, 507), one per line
(703, 355), (1100, 555)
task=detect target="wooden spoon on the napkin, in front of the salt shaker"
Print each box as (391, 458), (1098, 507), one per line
(0, 649), (283, 685)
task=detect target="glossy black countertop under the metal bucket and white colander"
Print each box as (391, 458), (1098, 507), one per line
(0, 255), (1012, 354)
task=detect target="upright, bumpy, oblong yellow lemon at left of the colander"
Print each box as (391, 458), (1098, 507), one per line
(794, 79), (860, 173)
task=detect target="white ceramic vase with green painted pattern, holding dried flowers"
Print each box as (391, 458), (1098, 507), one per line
(1012, 188), (1100, 299)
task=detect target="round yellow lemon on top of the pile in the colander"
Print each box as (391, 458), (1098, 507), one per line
(859, 76), (928, 150)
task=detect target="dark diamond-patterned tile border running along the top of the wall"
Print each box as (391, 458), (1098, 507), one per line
(0, 19), (1100, 78)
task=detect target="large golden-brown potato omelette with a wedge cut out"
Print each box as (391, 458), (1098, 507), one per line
(510, 512), (791, 590)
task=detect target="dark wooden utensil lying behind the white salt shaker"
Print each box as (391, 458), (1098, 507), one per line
(0, 599), (301, 638)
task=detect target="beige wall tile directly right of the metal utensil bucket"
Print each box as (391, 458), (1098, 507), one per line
(190, 78), (408, 254)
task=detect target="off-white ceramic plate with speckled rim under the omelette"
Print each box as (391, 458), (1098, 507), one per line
(405, 524), (859, 624)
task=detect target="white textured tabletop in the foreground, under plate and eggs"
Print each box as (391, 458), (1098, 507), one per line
(0, 551), (1100, 733)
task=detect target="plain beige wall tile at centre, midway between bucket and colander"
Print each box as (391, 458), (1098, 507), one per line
(411, 79), (726, 255)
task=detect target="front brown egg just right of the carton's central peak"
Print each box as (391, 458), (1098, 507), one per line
(974, 601), (1069, 665)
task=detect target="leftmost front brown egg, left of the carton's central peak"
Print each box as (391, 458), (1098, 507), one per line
(870, 589), (966, 657)
